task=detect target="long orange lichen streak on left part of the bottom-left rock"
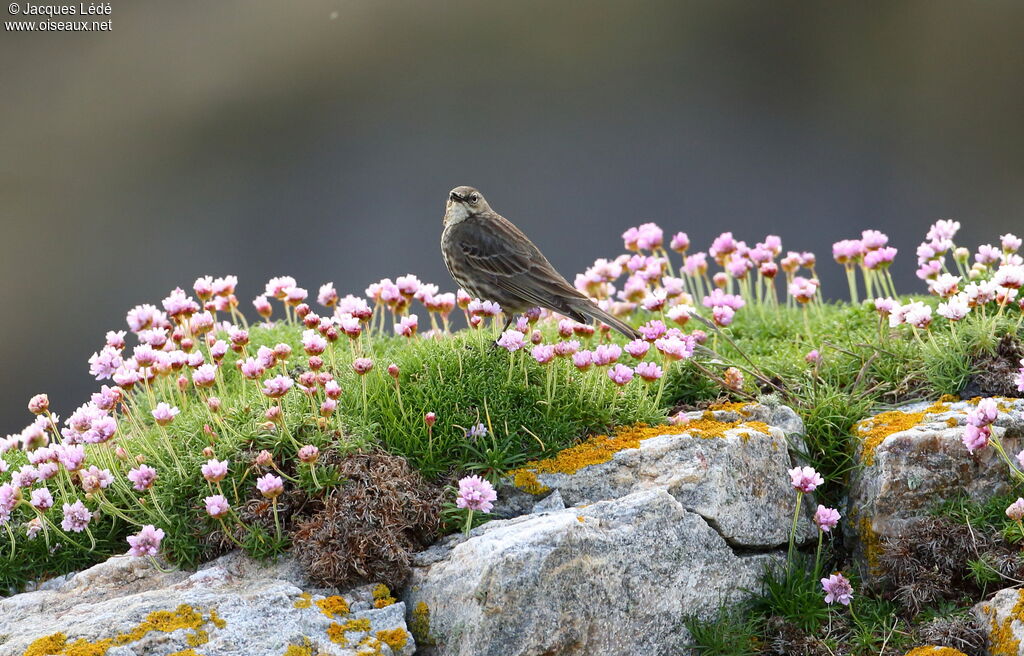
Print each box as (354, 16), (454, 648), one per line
(23, 604), (214, 656)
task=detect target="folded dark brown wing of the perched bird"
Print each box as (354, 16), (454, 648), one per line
(455, 215), (586, 309)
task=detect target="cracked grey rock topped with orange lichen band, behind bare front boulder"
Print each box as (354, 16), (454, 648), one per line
(496, 403), (814, 549)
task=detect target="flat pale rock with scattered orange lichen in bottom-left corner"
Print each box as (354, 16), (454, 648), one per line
(0, 553), (416, 656)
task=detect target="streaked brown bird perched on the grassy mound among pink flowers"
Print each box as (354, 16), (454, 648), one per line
(441, 186), (640, 339)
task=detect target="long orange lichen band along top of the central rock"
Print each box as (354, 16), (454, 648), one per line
(510, 412), (771, 478)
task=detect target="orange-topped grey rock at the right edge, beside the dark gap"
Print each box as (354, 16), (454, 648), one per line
(844, 398), (1024, 584)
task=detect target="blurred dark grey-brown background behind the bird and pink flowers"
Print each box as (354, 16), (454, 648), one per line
(0, 0), (1024, 434)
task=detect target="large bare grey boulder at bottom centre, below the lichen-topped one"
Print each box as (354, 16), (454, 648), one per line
(404, 488), (784, 656)
